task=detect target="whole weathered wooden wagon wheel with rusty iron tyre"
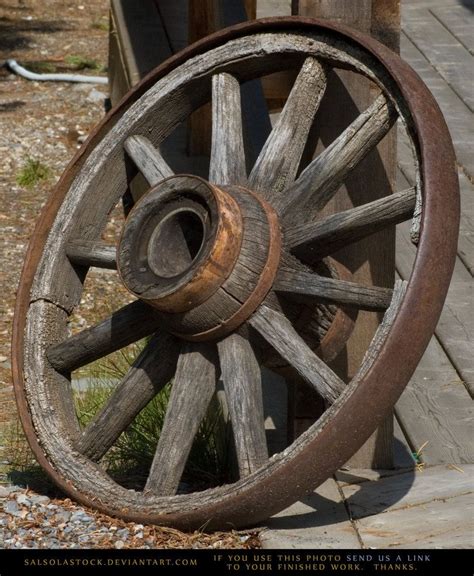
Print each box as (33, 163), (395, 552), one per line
(14, 19), (458, 528)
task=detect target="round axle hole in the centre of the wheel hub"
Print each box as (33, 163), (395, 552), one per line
(147, 208), (204, 278)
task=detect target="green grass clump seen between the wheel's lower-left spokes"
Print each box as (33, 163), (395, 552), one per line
(76, 350), (232, 491)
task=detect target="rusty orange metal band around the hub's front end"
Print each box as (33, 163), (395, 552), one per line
(118, 174), (243, 313)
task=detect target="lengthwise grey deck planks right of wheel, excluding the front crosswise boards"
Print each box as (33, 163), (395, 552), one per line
(396, 0), (474, 465)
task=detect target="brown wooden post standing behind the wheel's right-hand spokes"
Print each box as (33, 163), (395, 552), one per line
(292, 0), (400, 468)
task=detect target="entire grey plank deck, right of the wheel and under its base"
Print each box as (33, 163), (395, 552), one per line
(263, 0), (474, 548)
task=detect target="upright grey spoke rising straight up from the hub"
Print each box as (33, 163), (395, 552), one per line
(209, 73), (247, 184)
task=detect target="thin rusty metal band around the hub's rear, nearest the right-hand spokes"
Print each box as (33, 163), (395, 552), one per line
(174, 186), (282, 342)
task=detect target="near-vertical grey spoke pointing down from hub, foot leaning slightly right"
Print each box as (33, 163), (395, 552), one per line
(217, 333), (268, 478)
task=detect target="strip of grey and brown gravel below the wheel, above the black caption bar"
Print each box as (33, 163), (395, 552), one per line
(0, 486), (259, 549)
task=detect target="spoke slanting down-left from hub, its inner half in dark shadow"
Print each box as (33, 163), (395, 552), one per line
(46, 300), (160, 372)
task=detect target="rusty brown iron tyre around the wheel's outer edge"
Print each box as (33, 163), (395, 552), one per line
(12, 17), (459, 529)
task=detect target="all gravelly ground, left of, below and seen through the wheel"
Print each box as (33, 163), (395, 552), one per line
(0, 0), (259, 549)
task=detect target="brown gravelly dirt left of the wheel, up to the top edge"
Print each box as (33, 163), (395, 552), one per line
(0, 0), (109, 423)
